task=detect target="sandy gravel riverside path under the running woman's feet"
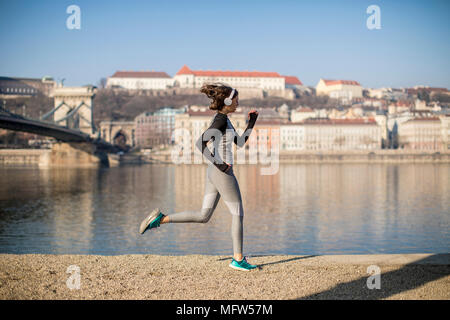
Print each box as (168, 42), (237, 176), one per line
(0, 253), (450, 300)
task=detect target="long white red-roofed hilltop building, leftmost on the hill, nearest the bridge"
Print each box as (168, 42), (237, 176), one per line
(106, 71), (174, 90)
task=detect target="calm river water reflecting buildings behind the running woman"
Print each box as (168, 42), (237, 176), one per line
(0, 164), (450, 255)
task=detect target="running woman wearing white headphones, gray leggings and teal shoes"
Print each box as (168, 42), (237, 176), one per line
(139, 83), (258, 271)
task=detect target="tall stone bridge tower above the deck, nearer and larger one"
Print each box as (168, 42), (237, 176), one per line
(53, 86), (97, 136)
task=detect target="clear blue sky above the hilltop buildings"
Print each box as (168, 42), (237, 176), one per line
(0, 0), (450, 88)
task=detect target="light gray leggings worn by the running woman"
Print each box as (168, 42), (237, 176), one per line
(169, 164), (244, 254)
